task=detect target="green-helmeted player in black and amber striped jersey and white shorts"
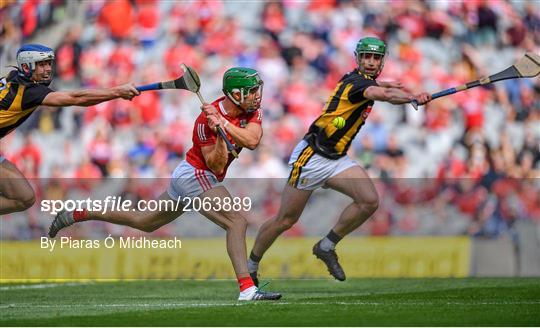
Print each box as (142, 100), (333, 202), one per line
(248, 37), (431, 282)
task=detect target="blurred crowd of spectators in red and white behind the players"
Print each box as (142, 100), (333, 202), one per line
(0, 0), (540, 238)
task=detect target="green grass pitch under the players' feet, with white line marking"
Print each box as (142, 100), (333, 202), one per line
(0, 278), (540, 326)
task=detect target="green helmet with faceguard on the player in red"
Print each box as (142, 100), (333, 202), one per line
(223, 67), (264, 113)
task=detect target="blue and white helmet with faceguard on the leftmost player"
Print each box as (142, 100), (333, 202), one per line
(17, 44), (54, 85)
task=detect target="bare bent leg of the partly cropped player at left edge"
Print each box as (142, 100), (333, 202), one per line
(0, 159), (36, 215)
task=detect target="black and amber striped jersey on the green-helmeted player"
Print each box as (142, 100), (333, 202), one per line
(304, 69), (377, 159)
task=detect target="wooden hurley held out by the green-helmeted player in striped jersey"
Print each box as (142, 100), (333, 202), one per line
(411, 52), (540, 110)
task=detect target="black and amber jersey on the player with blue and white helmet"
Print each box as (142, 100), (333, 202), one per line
(0, 71), (53, 139)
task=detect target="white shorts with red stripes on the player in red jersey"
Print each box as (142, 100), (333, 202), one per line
(167, 161), (221, 200)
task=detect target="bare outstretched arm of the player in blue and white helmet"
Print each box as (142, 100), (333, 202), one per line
(42, 83), (140, 107)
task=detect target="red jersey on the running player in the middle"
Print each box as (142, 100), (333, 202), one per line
(186, 97), (262, 181)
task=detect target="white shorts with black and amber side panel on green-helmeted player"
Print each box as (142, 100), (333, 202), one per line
(287, 140), (358, 190)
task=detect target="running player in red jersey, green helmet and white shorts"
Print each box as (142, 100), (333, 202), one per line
(49, 67), (281, 301)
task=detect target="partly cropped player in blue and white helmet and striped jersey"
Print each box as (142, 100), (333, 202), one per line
(0, 44), (139, 215)
